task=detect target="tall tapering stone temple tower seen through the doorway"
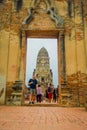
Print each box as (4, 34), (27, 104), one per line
(34, 47), (53, 91)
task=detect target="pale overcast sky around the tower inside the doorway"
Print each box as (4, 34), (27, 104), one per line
(26, 38), (58, 87)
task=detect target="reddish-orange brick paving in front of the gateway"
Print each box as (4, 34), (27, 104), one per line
(0, 106), (87, 130)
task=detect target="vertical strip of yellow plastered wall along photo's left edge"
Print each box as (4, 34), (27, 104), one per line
(0, 3), (11, 104)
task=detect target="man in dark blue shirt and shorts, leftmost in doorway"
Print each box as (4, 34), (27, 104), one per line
(28, 75), (37, 104)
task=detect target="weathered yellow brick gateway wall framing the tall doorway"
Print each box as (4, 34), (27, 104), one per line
(0, 0), (87, 106)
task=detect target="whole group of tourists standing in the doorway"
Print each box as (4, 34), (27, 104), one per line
(28, 75), (58, 104)
